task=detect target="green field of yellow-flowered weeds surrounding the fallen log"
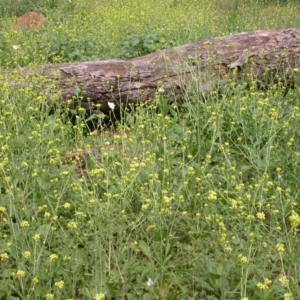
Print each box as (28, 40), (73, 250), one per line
(0, 0), (300, 300)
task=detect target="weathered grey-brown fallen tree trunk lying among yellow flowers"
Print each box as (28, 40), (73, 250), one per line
(2, 29), (300, 112)
